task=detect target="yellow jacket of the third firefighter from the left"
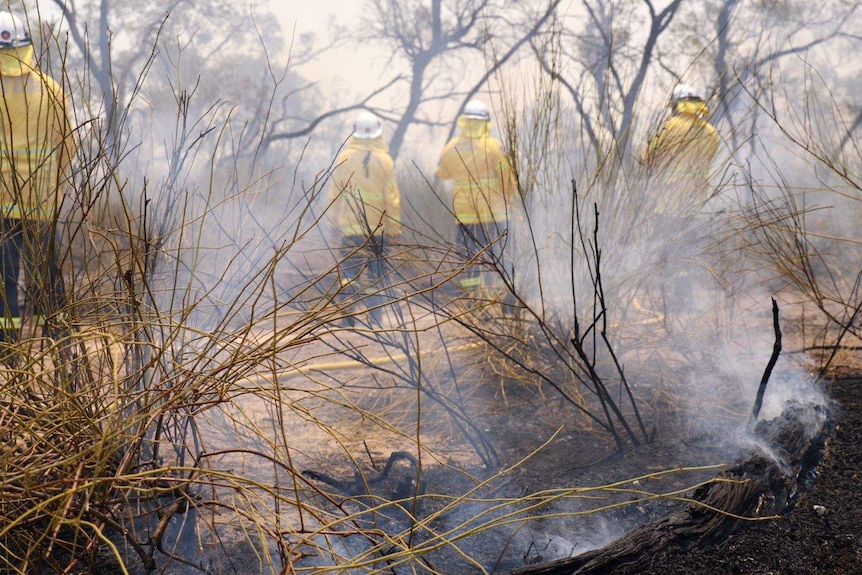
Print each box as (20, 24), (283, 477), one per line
(437, 116), (515, 224)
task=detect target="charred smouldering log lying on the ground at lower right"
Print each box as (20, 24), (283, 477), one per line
(510, 403), (828, 575)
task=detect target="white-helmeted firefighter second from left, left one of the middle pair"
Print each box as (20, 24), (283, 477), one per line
(330, 112), (401, 325)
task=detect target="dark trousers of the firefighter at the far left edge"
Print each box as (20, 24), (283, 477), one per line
(0, 218), (65, 328)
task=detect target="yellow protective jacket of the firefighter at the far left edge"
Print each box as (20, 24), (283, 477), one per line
(0, 46), (75, 220)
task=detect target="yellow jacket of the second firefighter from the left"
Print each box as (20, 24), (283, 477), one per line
(329, 136), (401, 238)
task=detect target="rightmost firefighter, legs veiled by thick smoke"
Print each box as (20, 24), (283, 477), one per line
(644, 84), (719, 311)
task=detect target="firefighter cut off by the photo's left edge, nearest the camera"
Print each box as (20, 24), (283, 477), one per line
(0, 11), (75, 340)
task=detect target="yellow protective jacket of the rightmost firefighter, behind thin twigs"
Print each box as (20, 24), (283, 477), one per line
(644, 100), (719, 194)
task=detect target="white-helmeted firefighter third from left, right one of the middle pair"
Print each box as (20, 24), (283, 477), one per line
(437, 100), (516, 309)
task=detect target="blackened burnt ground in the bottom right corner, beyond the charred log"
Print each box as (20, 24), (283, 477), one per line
(628, 377), (862, 575)
